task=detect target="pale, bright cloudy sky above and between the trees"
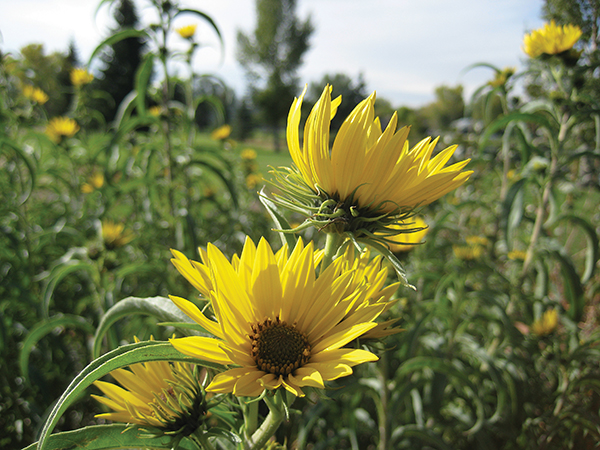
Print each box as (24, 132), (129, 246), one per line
(0, 0), (544, 107)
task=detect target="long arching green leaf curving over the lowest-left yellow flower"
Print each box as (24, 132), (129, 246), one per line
(38, 341), (223, 450)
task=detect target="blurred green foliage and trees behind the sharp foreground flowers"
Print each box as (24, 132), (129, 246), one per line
(0, 0), (600, 450)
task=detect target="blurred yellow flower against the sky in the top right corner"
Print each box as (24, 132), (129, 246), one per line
(523, 20), (581, 58)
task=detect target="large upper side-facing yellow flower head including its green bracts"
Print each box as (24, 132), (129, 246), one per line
(274, 85), (472, 236)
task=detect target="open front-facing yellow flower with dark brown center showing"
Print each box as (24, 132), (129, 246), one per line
(171, 238), (388, 397)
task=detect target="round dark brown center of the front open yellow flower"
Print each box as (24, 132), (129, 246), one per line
(248, 317), (310, 376)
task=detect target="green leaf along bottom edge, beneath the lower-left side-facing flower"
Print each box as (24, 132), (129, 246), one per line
(23, 424), (197, 450)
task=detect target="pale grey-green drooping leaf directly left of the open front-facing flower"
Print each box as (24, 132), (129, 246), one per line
(92, 297), (203, 358)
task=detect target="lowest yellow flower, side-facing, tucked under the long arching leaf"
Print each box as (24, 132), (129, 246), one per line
(92, 339), (208, 435)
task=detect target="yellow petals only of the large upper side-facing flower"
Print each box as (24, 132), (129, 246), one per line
(287, 86), (472, 216)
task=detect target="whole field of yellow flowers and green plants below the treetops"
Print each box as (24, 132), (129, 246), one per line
(0, 6), (600, 450)
